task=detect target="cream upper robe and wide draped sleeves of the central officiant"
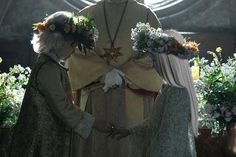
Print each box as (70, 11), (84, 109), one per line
(68, 0), (161, 91)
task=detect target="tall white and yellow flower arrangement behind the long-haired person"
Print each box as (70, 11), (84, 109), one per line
(193, 47), (236, 134)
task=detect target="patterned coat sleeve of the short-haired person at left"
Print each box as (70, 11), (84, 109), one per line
(37, 62), (95, 138)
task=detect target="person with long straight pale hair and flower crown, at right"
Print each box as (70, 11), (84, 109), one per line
(113, 30), (198, 157)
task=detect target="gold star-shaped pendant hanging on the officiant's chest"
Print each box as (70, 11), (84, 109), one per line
(102, 47), (123, 64)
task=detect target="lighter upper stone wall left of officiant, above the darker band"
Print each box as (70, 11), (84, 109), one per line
(0, 0), (73, 39)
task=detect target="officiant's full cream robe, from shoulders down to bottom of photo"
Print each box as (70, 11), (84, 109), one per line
(67, 0), (162, 157)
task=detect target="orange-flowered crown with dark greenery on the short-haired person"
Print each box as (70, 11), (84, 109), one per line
(33, 13), (98, 53)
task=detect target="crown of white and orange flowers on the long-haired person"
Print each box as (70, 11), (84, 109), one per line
(131, 22), (199, 59)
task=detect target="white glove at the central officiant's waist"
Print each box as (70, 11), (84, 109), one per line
(102, 69), (125, 92)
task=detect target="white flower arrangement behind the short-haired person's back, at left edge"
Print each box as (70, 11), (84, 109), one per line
(0, 59), (31, 127)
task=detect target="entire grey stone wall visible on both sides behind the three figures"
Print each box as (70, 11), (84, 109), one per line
(0, 0), (236, 69)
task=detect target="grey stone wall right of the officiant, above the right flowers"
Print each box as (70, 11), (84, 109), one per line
(156, 0), (236, 59)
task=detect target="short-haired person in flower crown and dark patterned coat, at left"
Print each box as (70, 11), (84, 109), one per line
(9, 11), (112, 157)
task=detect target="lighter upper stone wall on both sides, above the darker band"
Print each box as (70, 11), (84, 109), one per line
(0, 0), (236, 39)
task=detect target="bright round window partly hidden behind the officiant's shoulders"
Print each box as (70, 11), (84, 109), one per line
(63, 0), (200, 18)
